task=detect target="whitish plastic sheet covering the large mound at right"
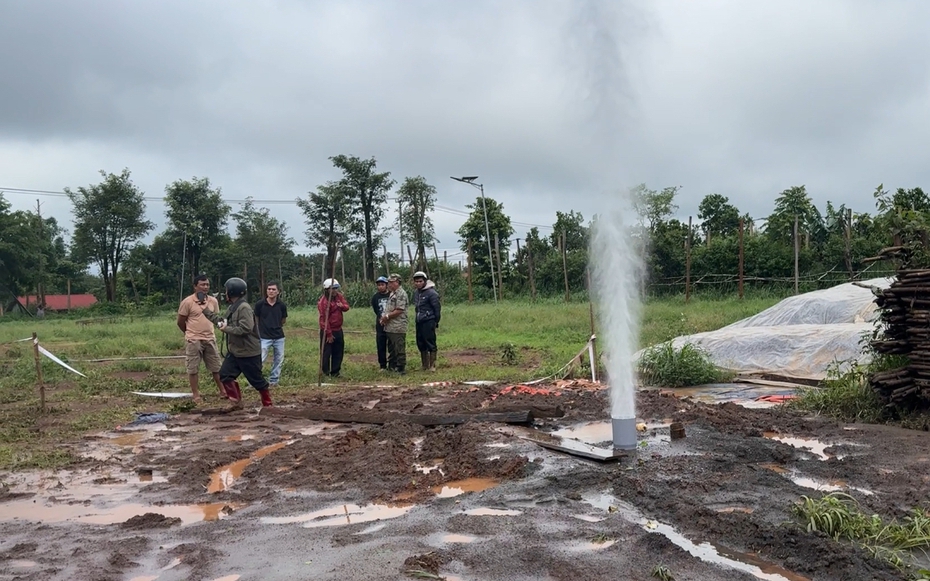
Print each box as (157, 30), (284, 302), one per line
(637, 278), (892, 379)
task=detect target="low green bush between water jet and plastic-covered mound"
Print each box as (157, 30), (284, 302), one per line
(637, 341), (727, 387)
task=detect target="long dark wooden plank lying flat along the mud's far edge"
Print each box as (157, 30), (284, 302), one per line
(259, 407), (533, 426)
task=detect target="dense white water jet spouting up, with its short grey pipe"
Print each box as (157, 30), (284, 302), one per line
(591, 199), (642, 450)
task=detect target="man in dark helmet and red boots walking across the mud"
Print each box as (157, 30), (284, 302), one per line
(203, 277), (271, 407)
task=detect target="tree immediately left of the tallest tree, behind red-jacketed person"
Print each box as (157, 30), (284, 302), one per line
(297, 182), (356, 278)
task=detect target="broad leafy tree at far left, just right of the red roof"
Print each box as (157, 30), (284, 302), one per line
(65, 168), (154, 302)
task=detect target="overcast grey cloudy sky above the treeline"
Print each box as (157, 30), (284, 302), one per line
(0, 0), (930, 254)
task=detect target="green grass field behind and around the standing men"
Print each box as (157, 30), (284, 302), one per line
(0, 297), (777, 469)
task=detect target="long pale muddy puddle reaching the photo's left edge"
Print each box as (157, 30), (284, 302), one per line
(0, 499), (241, 525)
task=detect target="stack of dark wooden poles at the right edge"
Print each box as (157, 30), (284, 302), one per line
(869, 269), (930, 407)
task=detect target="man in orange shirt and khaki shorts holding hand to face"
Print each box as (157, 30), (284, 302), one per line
(178, 274), (226, 402)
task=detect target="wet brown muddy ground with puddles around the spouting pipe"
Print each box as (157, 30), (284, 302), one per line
(0, 383), (930, 581)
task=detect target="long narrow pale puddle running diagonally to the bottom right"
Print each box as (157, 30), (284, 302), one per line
(582, 493), (810, 581)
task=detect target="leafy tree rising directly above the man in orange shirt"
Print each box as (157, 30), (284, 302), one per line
(165, 177), (230, 276)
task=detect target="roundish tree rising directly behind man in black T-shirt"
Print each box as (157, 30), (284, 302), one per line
(232, 197), (294, 294)
